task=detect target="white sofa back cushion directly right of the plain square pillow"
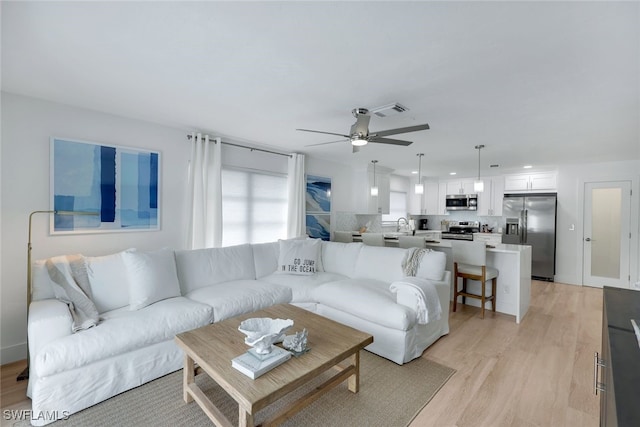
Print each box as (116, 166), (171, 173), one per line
(176, 245), (256, 295)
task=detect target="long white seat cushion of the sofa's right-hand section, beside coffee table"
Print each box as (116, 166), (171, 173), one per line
(311, 279), (416, 331)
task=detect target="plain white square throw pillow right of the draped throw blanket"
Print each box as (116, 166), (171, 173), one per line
(122, 248), (181, 311)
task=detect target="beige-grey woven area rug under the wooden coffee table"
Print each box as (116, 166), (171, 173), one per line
(47, 351), (455, 427)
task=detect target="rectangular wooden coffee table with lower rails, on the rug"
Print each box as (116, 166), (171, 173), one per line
(175, 304), (373, 427)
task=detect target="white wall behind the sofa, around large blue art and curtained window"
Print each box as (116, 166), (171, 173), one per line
(0, 92), (353, 364)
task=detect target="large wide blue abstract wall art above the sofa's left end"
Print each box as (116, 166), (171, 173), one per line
(51, 138), (160, 234)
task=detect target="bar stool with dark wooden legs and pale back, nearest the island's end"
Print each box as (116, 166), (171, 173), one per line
(451, 241), (498, 319)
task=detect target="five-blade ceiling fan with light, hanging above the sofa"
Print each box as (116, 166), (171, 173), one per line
(296, 108), (429, 153)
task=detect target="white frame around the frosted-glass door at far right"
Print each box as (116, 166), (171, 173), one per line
(576, 174), (640, 288)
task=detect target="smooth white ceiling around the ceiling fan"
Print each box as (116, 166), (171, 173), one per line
(1, 1), (640, 176)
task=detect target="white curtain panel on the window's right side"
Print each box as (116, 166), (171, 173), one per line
(287, 153), (306, 239)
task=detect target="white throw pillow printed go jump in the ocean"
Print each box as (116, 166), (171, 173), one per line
(278, 239), (320, 276)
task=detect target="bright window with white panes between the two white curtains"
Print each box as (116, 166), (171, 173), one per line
(222, 168), (287, 246)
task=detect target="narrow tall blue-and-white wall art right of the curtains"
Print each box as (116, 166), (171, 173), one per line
(305, 175), (331, 240)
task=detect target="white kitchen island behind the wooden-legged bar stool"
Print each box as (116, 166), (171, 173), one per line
(426, 240), (531, 323)
